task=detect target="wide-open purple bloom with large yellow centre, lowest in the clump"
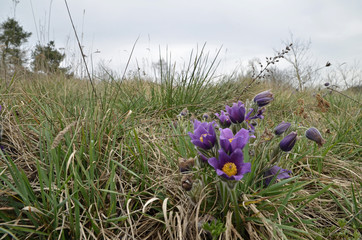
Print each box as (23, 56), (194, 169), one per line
(208, 149), (251, 181)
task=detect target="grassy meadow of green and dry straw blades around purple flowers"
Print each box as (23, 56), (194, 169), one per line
(0, 51), (362, 240)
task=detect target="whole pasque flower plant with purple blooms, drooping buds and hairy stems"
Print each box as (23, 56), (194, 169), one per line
(179, 91), (325, 236)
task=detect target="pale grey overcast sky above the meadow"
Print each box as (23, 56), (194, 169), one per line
(0, 0), (362, 76)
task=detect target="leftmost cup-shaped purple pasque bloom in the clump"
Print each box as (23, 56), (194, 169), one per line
(188, 120), (216, 150)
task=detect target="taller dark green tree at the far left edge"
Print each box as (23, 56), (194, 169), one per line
(0, 18), (31, 76)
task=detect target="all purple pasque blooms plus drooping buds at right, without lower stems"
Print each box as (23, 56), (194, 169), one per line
(184, 91), (325, 190)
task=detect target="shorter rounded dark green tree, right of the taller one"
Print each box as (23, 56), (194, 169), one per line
(31, 41), (65, 72)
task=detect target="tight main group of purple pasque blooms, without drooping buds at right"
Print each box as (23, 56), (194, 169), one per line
(188, 91), (273, 181)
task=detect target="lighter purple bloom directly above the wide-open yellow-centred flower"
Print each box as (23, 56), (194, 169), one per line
(220, 128), (249, 154)
